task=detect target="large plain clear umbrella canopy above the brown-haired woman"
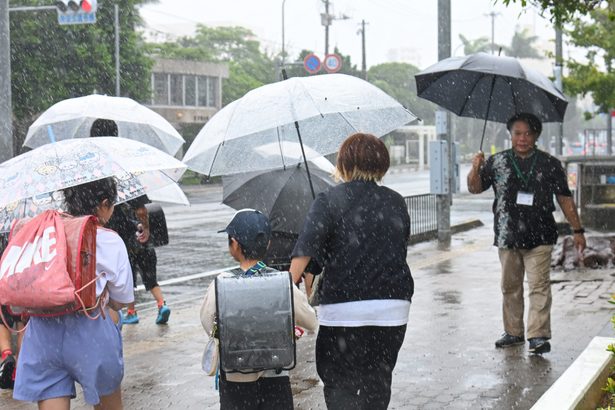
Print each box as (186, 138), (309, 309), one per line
(183, 74), (416, 176)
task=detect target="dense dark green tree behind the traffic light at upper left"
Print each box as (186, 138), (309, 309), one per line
(10, 0), (151, 152)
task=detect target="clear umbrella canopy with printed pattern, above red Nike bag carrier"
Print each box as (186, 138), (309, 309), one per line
(0, 137), (186, 232)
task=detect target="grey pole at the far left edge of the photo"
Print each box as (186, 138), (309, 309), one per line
(0, 0), (13, 162)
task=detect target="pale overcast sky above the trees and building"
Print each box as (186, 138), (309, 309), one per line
(141, 0), (555, 75)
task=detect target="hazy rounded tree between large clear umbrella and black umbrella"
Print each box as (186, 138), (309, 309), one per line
(367, 63), (436, 124)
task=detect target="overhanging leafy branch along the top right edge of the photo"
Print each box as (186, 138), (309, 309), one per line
(495, 0), (615, 24)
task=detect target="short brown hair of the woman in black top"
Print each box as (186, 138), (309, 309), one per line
(335, 133), (391, 182)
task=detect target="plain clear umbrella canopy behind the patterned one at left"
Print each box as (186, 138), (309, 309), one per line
(24, 94), (184, 155)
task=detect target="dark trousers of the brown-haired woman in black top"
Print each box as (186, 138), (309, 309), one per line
(316, 325), (406, 410)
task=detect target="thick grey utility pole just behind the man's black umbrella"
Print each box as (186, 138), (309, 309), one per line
(436, 0), (454, 243)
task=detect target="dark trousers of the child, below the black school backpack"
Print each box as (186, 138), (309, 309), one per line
(220, 374), (293, 410)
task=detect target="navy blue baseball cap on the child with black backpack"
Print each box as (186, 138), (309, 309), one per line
(218, 208), (271, 249)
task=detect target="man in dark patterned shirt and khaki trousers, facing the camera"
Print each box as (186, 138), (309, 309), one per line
(468, 113), (585, 354)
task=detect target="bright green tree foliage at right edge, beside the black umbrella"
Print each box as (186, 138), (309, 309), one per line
(564, 10), (615, 115)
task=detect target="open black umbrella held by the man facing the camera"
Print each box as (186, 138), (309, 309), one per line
(415, 53), (568, 151)
